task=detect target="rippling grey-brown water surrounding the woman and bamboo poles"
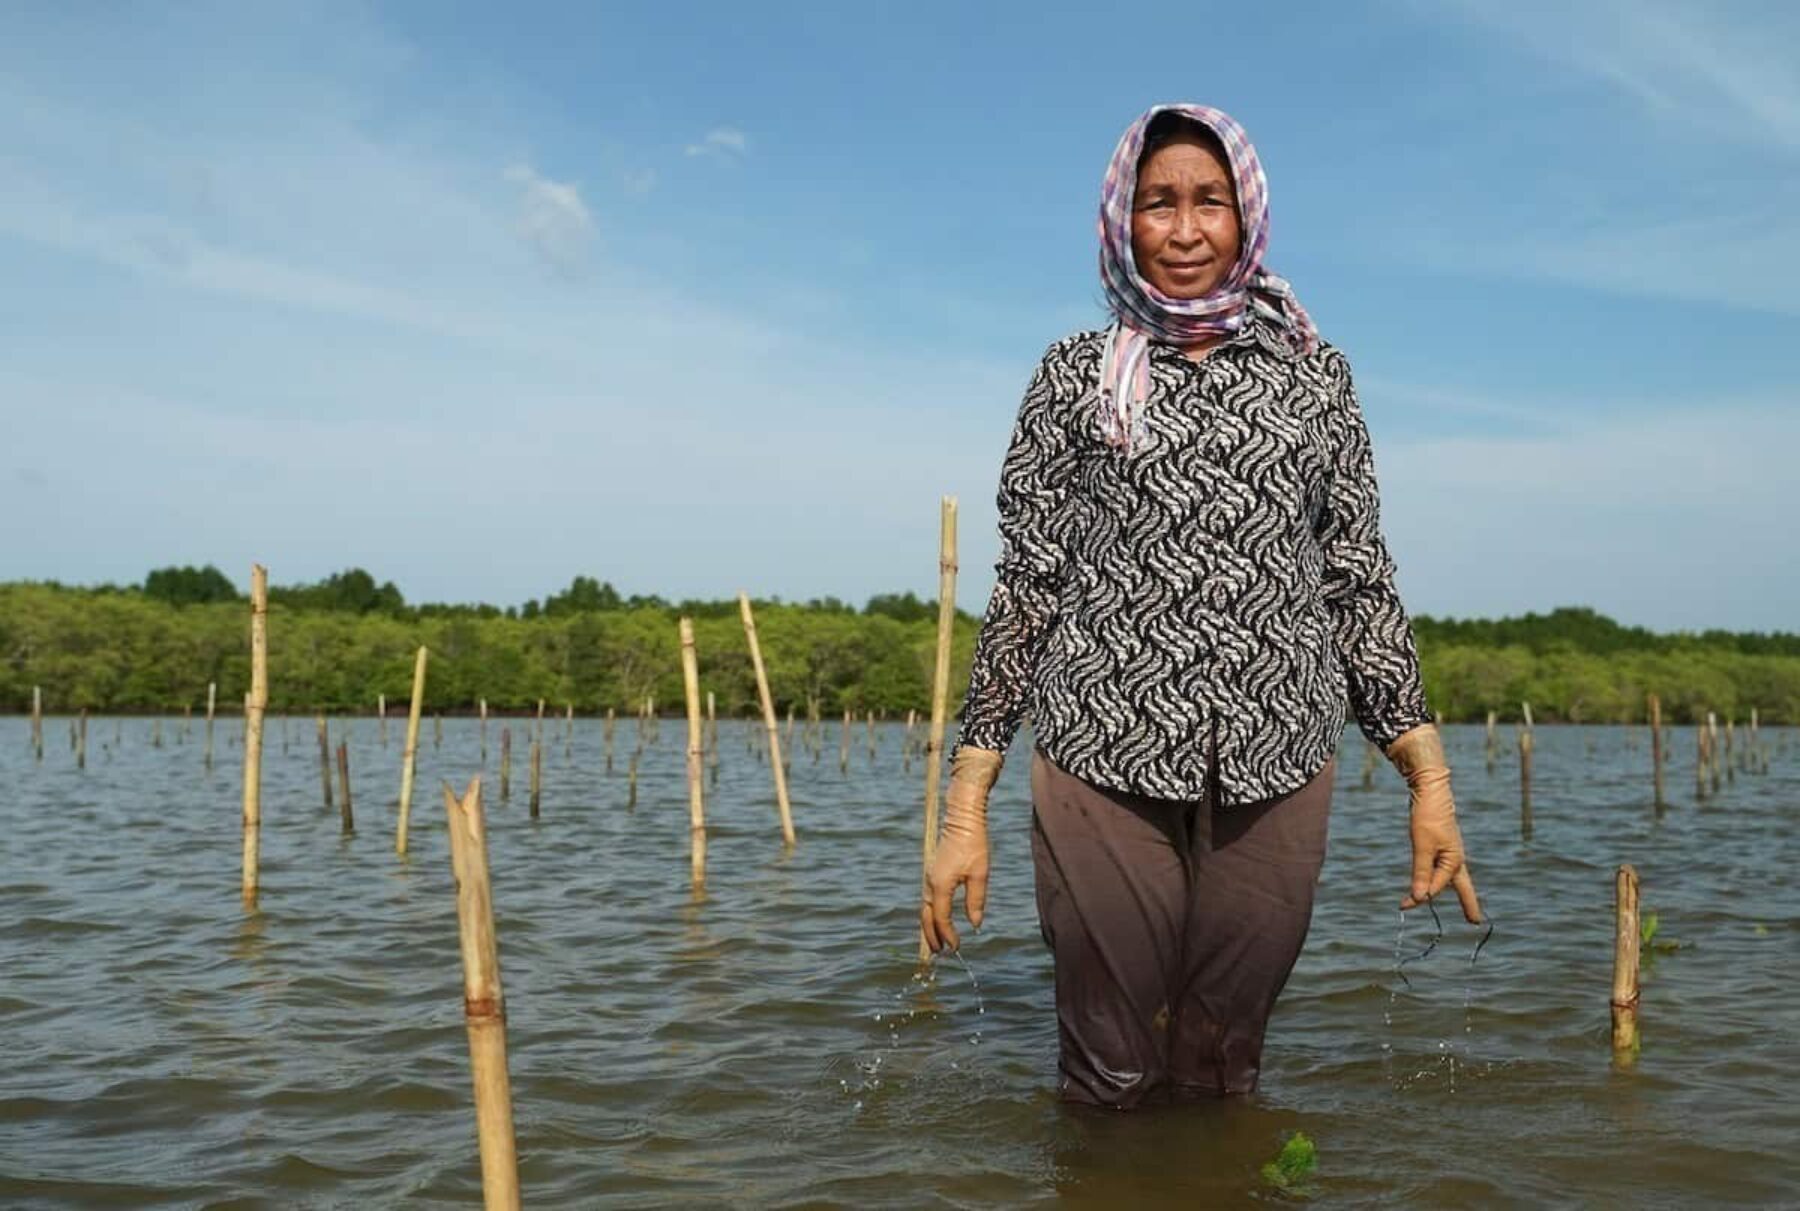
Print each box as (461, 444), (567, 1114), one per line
(0, 718), (1800, 1207)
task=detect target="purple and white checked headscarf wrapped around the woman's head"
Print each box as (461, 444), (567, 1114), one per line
(1100, 104), (1319, 450)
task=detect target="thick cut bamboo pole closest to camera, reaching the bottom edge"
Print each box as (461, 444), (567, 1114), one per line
(445, 777), (520, 1211)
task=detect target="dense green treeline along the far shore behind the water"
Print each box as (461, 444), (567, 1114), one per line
(0, 569), (1800, 723)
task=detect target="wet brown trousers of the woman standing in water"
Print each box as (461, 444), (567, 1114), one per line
(1031, 737), (1337, 1108)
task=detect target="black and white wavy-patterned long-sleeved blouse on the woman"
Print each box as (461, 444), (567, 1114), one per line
(958, 314), (1431, 804)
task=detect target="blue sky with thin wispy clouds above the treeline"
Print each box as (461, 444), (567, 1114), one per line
(0, 0), (1800, 630)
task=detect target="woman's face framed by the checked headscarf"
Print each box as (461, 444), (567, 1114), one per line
(1130, 135), (1242, 299)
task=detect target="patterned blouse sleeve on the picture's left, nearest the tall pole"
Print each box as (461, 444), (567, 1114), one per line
(952, 345), (1071, 756)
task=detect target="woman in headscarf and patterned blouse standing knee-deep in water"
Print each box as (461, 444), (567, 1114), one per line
(920, 104), (1481, 1108)
